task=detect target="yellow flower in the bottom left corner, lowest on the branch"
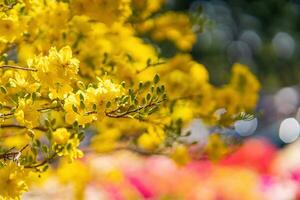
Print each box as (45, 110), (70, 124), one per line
(0, 161), (28, 199)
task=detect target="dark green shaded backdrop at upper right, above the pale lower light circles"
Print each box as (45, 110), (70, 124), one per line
(168, 0), (300, 91)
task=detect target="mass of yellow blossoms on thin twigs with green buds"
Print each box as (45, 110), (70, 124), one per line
(0, 0), (260, 198)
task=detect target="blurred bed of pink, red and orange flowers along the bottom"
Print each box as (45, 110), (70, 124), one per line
(25, 139), (300, 200)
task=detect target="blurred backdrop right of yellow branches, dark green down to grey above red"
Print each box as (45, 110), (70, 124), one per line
(165, 0), (300, 146)
